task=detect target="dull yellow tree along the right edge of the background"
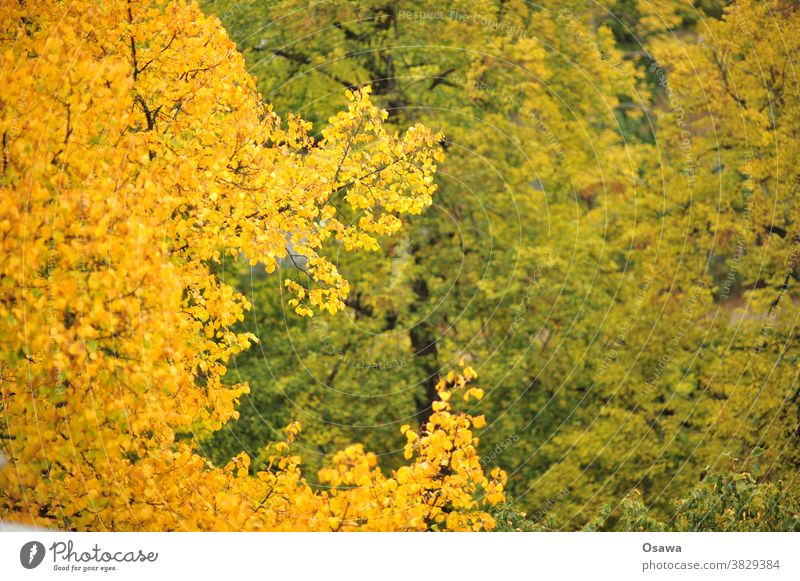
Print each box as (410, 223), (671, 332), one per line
(653, 0), (800, 483)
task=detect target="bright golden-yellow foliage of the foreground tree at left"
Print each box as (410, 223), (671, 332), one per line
(0, 0), (504, 530)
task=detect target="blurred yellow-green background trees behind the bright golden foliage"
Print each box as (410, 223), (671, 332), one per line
(208, 0), (797, 528)
